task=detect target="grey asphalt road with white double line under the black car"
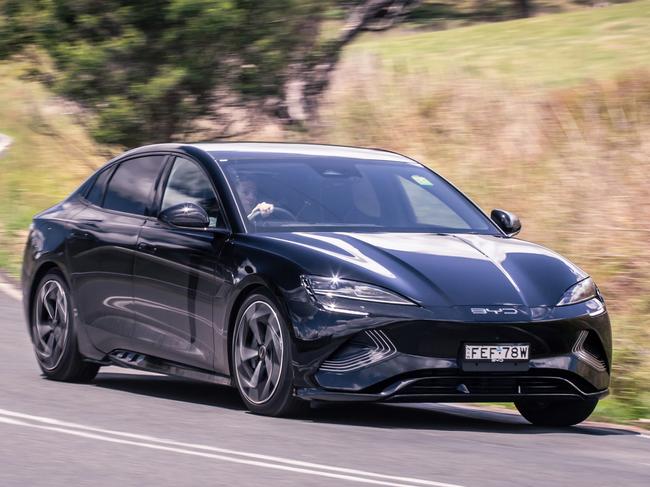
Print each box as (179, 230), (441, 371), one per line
(0, 280), (650, 487)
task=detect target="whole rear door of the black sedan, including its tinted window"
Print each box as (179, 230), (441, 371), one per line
(66, 155), (165, 353)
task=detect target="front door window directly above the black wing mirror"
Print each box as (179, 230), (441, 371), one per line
(160, 157), (226, 228)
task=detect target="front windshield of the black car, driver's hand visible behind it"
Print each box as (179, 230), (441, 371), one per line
(214, 154), (499, 235)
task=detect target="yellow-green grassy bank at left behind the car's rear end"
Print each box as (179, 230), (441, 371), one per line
(0, 62), (112, 275)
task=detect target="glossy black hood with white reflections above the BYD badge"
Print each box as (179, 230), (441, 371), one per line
(257, 232), (587, 307)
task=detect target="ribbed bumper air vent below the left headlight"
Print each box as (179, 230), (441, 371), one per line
(320, 330), (397, 372)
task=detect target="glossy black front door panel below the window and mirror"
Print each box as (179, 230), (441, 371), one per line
(133, 225), (227, 369)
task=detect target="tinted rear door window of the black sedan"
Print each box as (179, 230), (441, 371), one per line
(103, 156), (165, 215)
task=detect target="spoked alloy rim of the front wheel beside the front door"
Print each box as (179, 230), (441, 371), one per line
(235, 301), (283, 404)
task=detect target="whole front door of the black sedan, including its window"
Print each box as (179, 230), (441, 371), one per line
(134, 157), (230, 369)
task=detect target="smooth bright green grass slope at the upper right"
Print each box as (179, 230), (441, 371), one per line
(344, 1), (650, 86)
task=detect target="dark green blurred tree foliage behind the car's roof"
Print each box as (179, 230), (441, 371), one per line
(0, 0), (417, 146)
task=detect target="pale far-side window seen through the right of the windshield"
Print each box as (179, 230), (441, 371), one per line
(399, 176), (470, 229)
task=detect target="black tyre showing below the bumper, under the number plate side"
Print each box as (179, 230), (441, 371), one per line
(515, 399), (598, 426)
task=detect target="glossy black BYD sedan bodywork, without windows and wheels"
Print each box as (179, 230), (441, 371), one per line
(23, 143), (611, 424)
